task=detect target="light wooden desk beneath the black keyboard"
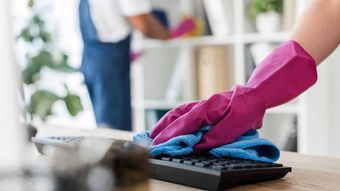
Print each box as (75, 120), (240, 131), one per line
(38, 126), (340, 191)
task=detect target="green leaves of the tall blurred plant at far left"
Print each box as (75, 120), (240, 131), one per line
(19, 10), (83, 121)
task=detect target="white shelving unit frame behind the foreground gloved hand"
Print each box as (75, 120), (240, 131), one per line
(133, 0), (305, 149)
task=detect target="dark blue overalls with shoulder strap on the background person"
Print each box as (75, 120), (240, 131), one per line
(79, 0), (132, 130)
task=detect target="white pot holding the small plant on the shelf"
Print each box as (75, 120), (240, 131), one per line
(256, 11), (281, 33)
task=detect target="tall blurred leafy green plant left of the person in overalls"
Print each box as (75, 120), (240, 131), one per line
(18, 0), (83, 121)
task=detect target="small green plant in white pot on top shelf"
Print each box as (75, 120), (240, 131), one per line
(248, 0), (283, 33)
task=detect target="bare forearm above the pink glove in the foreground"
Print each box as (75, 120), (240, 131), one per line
(291, 0), (340, 64)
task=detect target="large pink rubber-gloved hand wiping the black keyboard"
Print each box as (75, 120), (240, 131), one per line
(150, 41), (317, 153)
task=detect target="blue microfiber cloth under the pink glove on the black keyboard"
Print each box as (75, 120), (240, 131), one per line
(133, 126), (280, 162)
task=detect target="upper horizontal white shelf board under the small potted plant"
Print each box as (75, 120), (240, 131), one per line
(140, 32), (289, 49)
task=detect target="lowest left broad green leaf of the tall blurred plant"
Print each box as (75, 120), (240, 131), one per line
(28, 90), (60, 121)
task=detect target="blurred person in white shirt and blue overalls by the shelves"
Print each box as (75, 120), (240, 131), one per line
(79, 0), (170, 131)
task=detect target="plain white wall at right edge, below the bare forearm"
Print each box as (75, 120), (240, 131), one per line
(301, 48), (340, 157)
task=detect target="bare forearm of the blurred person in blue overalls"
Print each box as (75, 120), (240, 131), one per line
(129, 14), (170, 40)
